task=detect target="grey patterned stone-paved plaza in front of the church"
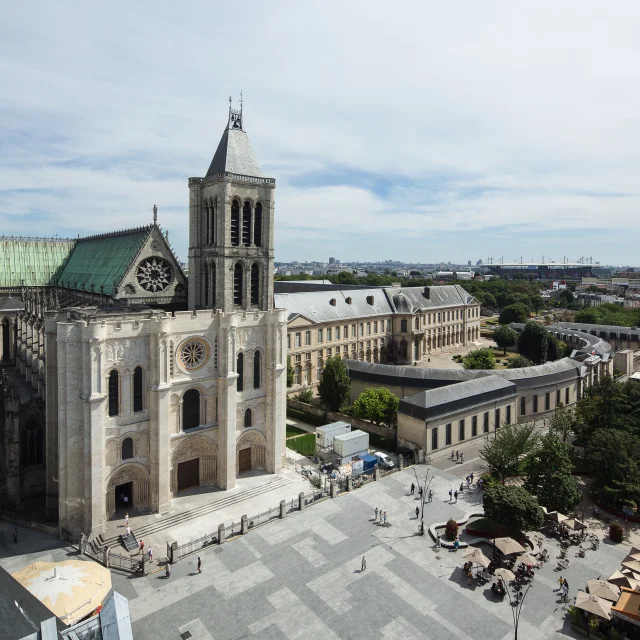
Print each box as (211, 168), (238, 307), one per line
(0, 466), (629, 640)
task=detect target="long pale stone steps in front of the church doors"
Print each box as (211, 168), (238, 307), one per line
(94, 476), (292, 550)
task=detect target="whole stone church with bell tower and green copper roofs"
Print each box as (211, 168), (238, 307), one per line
(0, 102), (286, 535)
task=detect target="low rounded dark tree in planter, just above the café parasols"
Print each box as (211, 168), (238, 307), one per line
(483, 484), (544, 534)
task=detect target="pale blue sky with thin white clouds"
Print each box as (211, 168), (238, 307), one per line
(0, 0), (640, 266)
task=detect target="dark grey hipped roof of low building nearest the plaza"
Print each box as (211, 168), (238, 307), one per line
(398, 375), (518, 420)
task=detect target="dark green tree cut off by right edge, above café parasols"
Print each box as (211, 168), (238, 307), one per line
(586, 429), (640, 508)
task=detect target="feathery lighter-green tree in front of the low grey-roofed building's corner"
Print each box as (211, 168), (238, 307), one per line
(479, 423), (540, 480)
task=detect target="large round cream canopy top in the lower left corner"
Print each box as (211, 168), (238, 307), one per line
(13, 560), (111, 625)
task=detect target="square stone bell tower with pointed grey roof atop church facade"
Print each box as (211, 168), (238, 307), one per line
(189, 105), (276, 312)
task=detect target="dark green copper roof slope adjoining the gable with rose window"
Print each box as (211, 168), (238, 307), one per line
(55, 226), (151, 295)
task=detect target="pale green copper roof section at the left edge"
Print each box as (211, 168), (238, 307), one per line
(0, 236), (76, 287)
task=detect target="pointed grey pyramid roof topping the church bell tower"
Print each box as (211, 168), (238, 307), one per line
(206, 104), (265, 178)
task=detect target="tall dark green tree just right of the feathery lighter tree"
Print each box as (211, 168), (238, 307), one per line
(524, 433), (581, 513)
